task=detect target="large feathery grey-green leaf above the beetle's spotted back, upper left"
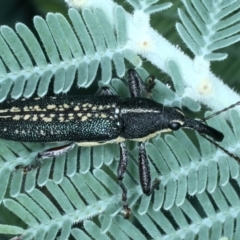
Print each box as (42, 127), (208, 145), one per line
(0, 8), (141, 101)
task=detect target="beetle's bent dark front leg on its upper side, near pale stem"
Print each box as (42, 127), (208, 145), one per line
(128, 69), (155, 97)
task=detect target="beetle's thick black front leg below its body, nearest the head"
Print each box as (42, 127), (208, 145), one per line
(138, 142), (160, 196)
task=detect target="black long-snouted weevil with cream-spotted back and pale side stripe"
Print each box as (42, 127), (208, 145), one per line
(0, 69), (224, 215)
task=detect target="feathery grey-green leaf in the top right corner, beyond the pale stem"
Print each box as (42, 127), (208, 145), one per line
(176, 0), (240, 61)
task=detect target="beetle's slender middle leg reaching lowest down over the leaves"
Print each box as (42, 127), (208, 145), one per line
(117, 143), (131, 218)
